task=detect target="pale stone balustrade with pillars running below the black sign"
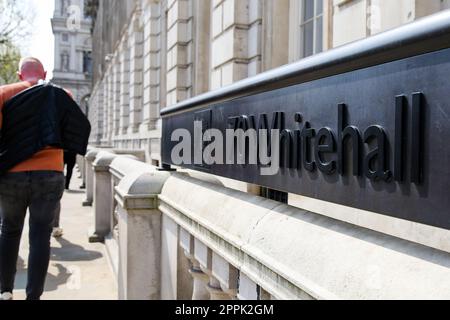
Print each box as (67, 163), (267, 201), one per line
(81, 150), (450, 300)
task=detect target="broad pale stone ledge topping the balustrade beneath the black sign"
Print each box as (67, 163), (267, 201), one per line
(159, 173), (450, 299)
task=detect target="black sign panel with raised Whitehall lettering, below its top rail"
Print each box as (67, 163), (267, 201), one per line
(162, 14), (450, 229)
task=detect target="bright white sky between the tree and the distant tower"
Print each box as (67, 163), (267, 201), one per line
(21, 0), (55, 80)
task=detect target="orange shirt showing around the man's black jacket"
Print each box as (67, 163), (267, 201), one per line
(0, 82), (64, 172)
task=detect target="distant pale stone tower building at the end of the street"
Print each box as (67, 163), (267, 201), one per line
(52, 0), (92, 111)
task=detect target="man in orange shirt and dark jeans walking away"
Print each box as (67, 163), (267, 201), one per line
(0, 58), (90, 300)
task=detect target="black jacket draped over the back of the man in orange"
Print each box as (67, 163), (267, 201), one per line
(0, 83), (91, 175)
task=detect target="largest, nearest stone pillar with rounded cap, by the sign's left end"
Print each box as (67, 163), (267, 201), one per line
(115, 170), (170, 300)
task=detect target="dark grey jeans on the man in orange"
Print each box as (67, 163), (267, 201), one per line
(0, 171), (64, 300)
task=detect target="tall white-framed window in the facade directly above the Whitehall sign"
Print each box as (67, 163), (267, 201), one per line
(300, 0), (324, 58)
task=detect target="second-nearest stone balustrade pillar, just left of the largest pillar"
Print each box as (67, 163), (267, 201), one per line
(89, 151), (117, 242)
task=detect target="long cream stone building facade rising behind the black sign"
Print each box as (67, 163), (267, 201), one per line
(88, 0), (450, 163)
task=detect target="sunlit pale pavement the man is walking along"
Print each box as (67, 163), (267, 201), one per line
(14, 170), (118, 300)
